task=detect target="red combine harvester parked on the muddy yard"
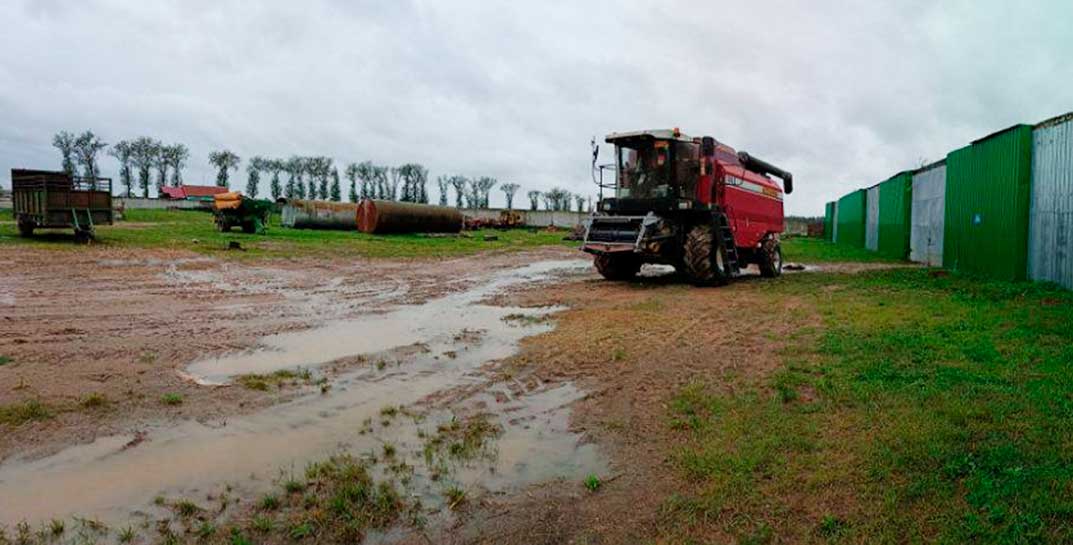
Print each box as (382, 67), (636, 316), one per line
(582, 129), (793, 285)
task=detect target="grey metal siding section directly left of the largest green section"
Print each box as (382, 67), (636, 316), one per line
(909, 165), (946, 267)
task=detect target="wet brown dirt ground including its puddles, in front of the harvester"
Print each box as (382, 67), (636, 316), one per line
(0, 248), (824, 543)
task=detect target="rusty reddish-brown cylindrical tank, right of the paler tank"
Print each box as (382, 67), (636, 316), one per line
(357, 198), (462, 235)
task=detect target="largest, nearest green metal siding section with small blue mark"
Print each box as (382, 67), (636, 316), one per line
(943, 126), (1032, 280)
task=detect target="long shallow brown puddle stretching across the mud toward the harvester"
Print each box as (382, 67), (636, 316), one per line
(0, 261), (602, 532)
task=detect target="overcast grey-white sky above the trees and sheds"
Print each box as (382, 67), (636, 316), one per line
(0, 0), (1073, 215)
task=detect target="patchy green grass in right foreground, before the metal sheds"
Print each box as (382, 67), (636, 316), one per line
(663, 269), (1073, 544)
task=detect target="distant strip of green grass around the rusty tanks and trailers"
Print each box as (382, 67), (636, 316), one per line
(0, 210), (576, 259)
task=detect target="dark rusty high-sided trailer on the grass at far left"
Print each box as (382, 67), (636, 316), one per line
(11, 168), (113, 240)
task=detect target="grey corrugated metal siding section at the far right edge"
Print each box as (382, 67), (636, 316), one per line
(1028, 119), (1073, 290)
